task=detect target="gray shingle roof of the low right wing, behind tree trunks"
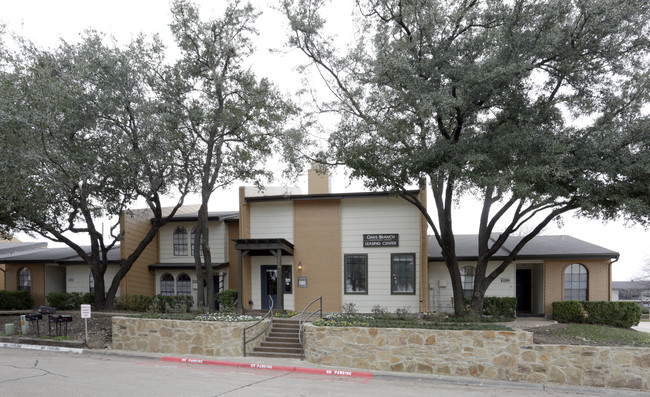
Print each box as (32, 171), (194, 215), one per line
(428, 234), (619, 261)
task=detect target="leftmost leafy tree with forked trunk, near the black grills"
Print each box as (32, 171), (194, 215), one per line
(0, 32), (191, 309)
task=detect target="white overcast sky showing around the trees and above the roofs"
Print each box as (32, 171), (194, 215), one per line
(0, 0), (650, 280)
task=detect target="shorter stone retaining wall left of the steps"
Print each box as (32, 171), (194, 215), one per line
(112, 317), (270, 357)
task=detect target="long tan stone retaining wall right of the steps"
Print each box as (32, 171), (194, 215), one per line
(304, 325), (650, 390)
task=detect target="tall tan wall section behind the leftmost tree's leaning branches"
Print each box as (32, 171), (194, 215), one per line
(120, 210), (159, 296)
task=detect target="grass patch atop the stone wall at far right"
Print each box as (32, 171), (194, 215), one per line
(544, 324), (650, 347)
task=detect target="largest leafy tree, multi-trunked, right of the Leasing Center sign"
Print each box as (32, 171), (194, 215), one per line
(283, 0), (650, 315)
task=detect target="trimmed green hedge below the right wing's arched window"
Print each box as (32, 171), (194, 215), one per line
(553, 300), (641, 328)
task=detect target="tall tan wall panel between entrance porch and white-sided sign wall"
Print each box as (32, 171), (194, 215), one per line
(293, 200), (343, 312)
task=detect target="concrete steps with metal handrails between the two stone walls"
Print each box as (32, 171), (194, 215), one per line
(247, 318), (302, 358)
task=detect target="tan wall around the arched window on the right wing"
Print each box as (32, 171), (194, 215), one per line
(544, 259), (611, 314)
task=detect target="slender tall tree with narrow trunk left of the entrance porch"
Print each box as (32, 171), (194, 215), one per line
(171, 0), (302, 308)
